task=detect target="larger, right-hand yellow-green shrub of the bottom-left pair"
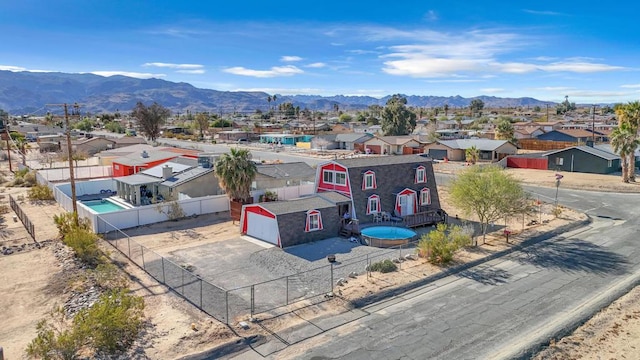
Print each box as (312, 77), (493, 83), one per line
(73, 289), (144, 354)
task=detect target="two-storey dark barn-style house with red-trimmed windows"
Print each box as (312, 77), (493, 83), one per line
(315, 155), (440, 222)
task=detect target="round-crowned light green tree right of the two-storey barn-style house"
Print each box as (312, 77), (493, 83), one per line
(450, 166), (526, 242)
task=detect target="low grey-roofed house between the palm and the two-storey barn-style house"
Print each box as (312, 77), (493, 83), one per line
(251, 162), (316, 190)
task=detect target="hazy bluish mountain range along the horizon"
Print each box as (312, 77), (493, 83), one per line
(0, 70), (555, 115)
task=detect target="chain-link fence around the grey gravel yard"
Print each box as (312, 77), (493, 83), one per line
(101, 212), (428, 324)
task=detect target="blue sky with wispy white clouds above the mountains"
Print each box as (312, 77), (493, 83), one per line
(0, 0), (640, 104)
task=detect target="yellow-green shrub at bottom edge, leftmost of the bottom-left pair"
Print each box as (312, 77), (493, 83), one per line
(26, 307), (83, 360)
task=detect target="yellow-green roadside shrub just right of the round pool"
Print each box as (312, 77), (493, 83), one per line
(416, 224), (471, 264)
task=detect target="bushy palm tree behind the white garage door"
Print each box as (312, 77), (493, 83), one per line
(215, 148), (257, 202)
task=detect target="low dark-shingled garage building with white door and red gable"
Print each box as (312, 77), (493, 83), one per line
(240, 192), (351, 248)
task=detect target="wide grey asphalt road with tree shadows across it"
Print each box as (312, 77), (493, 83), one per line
(239, 187), (640, 360)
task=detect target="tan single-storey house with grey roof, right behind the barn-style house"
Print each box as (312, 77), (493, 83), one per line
(424, 139), (518, 162)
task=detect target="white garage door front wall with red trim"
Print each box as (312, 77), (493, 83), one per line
(240, 205), (282, 247)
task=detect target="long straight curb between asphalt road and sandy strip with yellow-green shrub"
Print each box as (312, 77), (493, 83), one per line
(349, 215), (592, 308)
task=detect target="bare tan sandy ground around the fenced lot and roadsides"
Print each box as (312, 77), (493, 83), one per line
(0, 158), (640, 360)
